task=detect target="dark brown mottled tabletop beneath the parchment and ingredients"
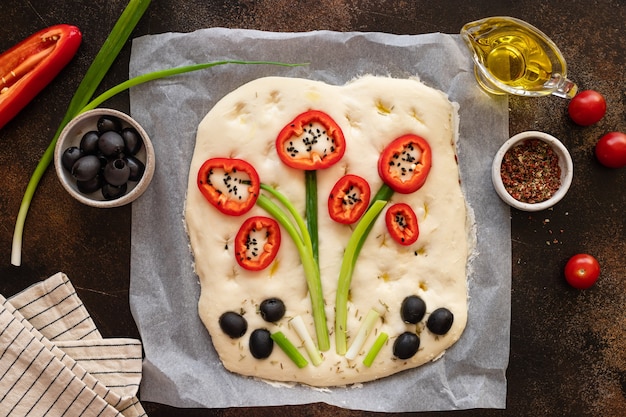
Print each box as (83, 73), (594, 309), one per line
(0, 0), (626, 417)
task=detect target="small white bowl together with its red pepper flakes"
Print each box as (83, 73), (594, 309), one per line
(491, 131), (574, 211)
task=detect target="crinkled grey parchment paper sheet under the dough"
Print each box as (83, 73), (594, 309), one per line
(130, 28), (511, 412)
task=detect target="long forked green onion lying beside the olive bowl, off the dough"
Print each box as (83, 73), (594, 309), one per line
(11, 0), (304, 266)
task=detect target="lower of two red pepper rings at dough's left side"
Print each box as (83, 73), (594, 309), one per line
(235, 216), (280, 271)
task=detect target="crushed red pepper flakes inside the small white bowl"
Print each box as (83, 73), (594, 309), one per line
(500, 139), (561, 204)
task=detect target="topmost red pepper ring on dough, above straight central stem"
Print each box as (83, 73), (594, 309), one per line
(276, 110), (346, 171)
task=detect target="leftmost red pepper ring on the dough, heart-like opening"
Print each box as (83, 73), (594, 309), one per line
(198, 158), (261, 216)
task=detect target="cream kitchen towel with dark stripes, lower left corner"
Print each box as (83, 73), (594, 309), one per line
(0, 273), (146, 417)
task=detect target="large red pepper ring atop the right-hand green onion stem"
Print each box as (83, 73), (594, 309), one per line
(378, 134), (432, 194)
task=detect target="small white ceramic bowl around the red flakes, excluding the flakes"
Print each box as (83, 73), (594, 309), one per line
(491, 131), (574, 211)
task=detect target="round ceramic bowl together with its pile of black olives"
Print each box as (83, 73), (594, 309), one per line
(54, 108), (155, 208)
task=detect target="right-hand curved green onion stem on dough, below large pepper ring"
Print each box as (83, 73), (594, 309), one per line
(335, 184), (393, 355)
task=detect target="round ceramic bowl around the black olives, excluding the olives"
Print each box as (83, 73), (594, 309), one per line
(54, 108), (155, 208)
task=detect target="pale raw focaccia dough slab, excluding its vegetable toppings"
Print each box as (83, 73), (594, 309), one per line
(185, 76), (469, 386)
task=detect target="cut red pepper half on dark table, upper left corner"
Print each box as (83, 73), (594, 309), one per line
(0, 25), (82, 129)
